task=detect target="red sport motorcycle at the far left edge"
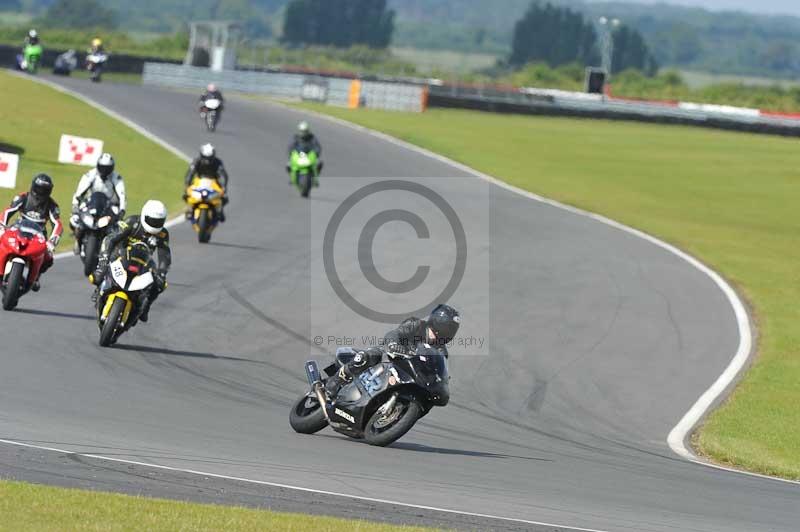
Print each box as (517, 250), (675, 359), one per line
(0, 219), (47, 310)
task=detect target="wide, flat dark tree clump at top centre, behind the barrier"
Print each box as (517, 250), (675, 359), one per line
(283, 0), (394, 48)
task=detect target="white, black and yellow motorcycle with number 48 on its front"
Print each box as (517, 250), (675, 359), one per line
(97, 242), (155, 347)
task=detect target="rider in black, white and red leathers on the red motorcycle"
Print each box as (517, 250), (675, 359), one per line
(0, 174), (64, 292)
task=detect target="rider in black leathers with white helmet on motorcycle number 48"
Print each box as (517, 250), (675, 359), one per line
(90, 200), (172, 323)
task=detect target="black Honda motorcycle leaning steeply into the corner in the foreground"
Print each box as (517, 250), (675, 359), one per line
(289, 344), (450, 447)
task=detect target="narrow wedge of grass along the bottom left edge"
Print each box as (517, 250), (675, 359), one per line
(0, 481), (438, 532)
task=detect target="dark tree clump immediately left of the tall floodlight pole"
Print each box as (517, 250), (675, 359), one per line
(509, 0), (597, 66)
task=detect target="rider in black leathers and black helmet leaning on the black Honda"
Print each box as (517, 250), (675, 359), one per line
(327, 304), (461, 396)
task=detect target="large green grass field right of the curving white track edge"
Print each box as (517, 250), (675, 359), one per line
(294, 105), (800, 479)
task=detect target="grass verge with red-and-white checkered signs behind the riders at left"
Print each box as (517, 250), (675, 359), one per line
(0, 72), (187, 249)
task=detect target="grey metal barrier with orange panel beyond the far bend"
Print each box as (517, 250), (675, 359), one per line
(144, 63), (426, 112)
